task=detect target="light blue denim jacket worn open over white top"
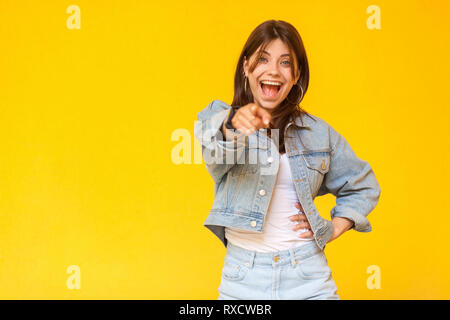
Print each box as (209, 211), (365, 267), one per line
(194, 100), (381, 250)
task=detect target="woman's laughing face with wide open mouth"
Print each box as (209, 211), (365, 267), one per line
(244, 39), (300, 112)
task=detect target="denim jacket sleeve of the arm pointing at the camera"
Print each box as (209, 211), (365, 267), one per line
(194, 100), (246, 183)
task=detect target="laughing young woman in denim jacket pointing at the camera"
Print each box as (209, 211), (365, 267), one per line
(194, 20), (380, 299)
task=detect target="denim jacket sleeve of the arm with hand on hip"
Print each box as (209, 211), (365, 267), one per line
(319, 127), (381, 232)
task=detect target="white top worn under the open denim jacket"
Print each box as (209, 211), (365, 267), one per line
(225, 153), (314, 252)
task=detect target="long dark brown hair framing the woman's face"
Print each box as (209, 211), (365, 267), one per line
(231, 20), (309, 153)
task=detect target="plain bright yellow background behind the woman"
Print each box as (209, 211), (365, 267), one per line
(0, 0), (450, 299)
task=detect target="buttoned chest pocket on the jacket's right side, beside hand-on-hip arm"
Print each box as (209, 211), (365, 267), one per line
(302, 150), (330, 198)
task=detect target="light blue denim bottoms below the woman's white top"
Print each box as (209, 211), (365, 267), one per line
(218, 241), (340, 300)
